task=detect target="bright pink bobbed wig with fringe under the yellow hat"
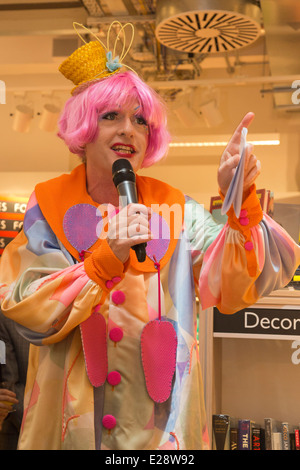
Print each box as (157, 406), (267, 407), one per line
(58, 71), (170, 167)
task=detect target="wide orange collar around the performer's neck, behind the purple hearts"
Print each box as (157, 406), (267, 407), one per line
(35, 164), (185, 272)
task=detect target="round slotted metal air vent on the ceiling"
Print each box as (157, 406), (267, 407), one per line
(156, 0), (261, 53)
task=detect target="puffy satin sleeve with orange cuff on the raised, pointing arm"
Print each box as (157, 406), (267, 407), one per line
(185, 185), (300, 314)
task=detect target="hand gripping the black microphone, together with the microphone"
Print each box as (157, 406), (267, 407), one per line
(107, 159), (151, 263)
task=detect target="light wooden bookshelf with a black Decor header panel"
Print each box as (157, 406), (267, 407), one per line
(199, 288), (300, 448)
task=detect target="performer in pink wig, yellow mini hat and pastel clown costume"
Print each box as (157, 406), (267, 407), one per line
(0, 23), (300, 450)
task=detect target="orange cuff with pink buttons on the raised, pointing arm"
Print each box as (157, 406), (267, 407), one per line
(220, 184), (263, 277)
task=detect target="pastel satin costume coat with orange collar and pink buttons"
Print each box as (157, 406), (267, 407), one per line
(0, 165), (300, 450)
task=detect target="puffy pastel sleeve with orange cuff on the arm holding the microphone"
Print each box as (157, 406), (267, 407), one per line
(0, 194), (125, 345)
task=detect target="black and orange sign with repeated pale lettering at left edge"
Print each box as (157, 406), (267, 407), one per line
(0, 195), (28, 255)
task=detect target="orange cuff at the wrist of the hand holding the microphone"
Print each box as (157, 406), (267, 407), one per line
(84, 239), (130, 291)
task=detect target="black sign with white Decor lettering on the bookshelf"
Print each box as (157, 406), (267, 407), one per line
(214, 306), (300, 339)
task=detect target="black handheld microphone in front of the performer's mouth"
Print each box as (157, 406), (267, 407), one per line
(112, 158), (147, 263)
